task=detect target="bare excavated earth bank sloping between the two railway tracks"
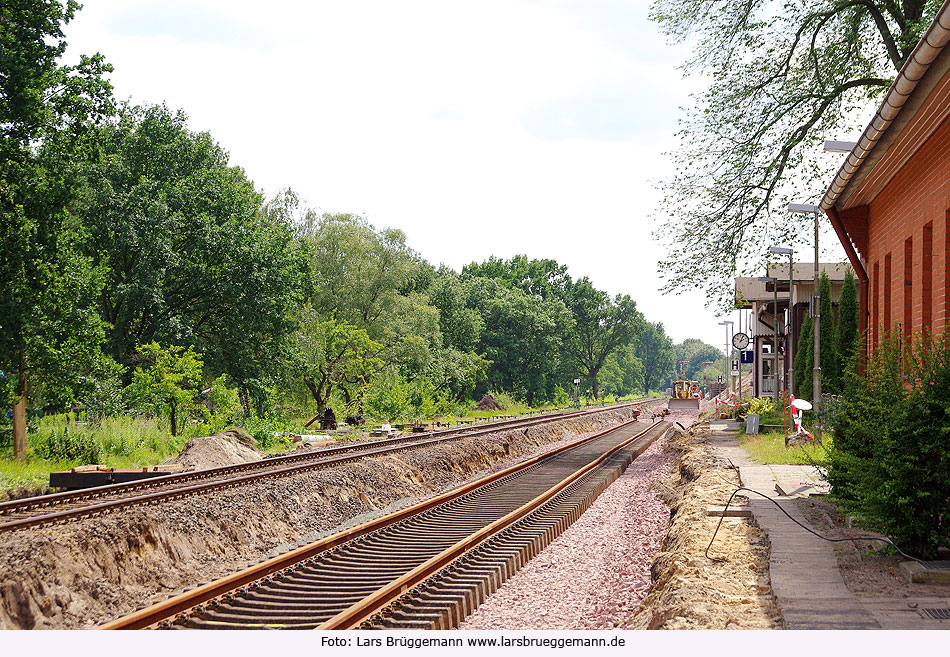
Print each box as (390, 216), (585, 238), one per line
(0, 409), (632, 629)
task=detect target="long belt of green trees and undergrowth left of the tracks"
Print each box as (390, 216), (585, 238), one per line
(0, 0), (708, 483)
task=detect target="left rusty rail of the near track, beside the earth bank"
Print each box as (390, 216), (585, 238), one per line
(100, 420), (656, 629)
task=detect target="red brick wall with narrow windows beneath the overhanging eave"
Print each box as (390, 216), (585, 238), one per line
(866, 113), (950, 344)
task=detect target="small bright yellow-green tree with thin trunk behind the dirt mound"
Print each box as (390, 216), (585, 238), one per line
(126, 342), (204, 436)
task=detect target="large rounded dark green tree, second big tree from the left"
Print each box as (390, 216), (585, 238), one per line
(83, 106), (302, 396)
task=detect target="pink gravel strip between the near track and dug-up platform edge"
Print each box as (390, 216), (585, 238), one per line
(459, 411), (697, 630)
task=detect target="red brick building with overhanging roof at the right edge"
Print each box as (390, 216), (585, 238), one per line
(820, 0), (950, 348)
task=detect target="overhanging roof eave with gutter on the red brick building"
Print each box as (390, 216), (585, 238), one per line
(819, 0), (950, 211)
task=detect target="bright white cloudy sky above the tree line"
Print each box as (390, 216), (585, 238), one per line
(59, 0), (844, 347)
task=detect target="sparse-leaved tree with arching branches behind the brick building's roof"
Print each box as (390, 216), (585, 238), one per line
(651, 0), (942, 308)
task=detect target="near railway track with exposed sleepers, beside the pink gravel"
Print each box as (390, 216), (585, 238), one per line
(102, 420), (670, 630)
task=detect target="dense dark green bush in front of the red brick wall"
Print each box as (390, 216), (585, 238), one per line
(826, 334), (950, 558)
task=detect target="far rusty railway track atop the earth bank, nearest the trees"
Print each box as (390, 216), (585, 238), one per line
(0, 400), (657, 533)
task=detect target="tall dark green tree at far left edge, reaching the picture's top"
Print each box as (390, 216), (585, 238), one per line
(0, 0), (112, 457)
